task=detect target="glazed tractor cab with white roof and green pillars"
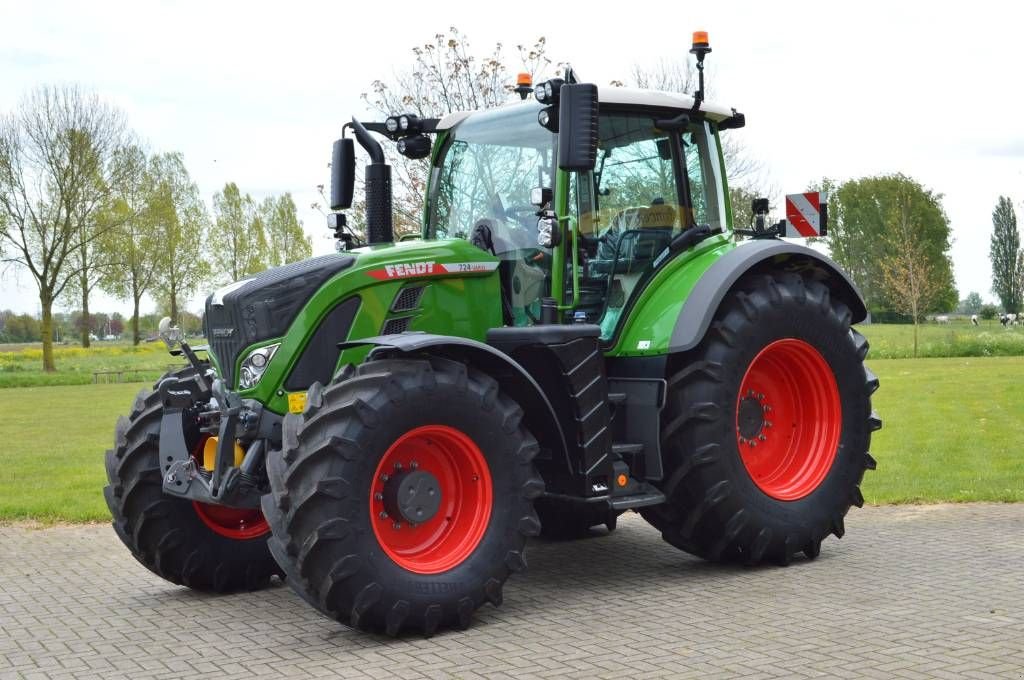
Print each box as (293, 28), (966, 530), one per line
(423, 92), (741, 340)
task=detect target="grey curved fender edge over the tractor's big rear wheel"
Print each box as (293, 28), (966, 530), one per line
(668, 240), (867, 352)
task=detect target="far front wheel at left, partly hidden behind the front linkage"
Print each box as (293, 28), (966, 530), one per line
(103, 368), (281, 593)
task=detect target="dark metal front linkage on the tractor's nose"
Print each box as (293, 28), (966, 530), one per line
(157, 343), (282, 508)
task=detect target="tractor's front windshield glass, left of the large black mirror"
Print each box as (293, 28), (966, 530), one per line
(427, 105), (555, 258)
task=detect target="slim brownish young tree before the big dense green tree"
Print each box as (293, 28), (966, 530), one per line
(881, 186), (944, 358)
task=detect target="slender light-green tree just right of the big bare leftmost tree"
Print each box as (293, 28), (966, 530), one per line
(99, 145), (163, 345)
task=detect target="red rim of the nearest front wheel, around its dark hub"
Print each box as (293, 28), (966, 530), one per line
(370, 425), (494, 573)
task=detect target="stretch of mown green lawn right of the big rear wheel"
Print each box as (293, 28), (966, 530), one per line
(863, 356), (1024, 503)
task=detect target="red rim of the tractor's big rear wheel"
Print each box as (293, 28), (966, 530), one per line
(736, 338), (843, 501)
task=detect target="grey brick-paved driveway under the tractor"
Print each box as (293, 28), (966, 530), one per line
(0, 505), (1024, 678)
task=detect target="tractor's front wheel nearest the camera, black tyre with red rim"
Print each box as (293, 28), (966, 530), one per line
(263, 357), (544, 635)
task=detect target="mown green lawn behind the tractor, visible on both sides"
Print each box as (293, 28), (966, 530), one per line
(0, 357), (1024, 521)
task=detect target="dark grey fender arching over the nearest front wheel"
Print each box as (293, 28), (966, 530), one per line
(338, 333), (572, 473)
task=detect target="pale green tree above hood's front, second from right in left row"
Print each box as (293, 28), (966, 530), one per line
(210, 182), (267, 282)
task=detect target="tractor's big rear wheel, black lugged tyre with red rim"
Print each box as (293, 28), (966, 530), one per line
(642, 272), (882, 564)
